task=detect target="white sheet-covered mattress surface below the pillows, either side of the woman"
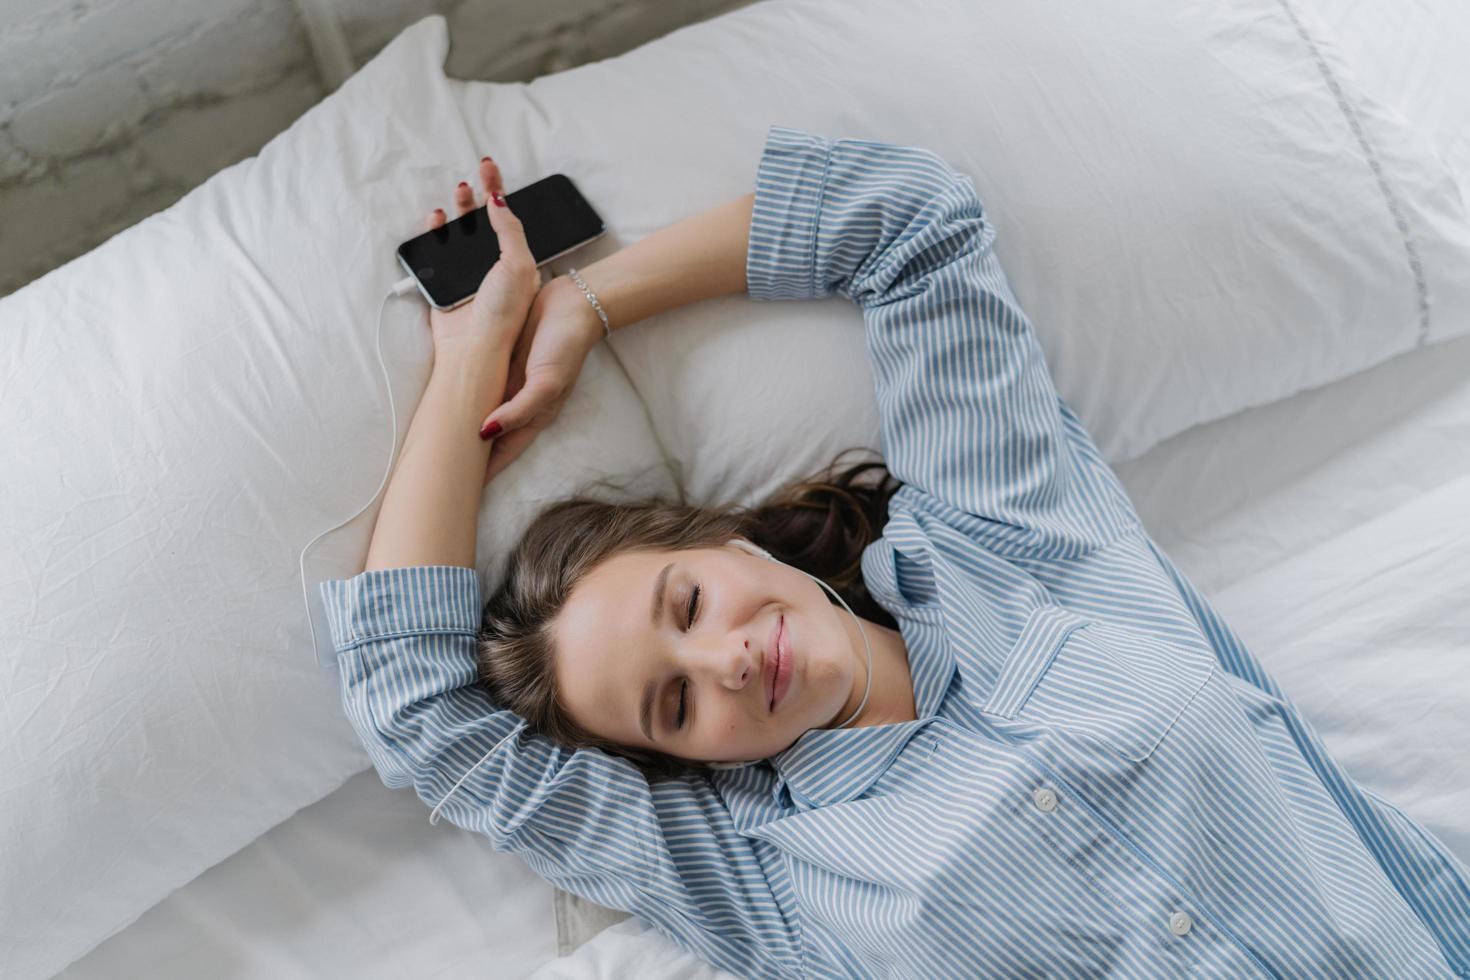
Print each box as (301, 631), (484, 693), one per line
(59, 310), (1470, 980)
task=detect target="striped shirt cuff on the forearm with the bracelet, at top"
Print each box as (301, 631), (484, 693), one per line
(745, 126), (832, 300)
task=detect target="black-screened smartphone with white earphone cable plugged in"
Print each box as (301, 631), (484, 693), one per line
(398, 173), (607, 310)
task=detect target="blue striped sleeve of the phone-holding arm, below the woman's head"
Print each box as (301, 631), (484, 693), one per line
(320, 566), (801, 977)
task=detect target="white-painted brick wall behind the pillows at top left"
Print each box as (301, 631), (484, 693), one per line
(0, 0), (753, 295)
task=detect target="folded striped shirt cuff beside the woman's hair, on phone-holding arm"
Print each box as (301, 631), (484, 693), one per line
(318, 564), (482, 652)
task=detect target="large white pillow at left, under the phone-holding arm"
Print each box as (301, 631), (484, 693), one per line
(0, 18), (678, 980)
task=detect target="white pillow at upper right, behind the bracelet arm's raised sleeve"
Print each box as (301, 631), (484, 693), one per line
(476, 0), (1470, 481)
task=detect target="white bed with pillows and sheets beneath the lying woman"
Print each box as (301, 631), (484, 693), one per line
(11, 0), (1470, 979)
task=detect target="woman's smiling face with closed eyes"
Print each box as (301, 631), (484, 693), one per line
(551, 545), (866, 763)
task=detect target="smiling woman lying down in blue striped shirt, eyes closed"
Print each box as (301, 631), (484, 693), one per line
(322, 126), (1470, 977)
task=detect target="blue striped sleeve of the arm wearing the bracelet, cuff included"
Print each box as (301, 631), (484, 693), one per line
(745, 126), (1139, 557)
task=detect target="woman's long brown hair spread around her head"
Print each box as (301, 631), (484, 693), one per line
(476, 453), (900, 783)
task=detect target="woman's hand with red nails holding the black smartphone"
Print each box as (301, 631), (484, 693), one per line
(425, 157), (541, 359)
